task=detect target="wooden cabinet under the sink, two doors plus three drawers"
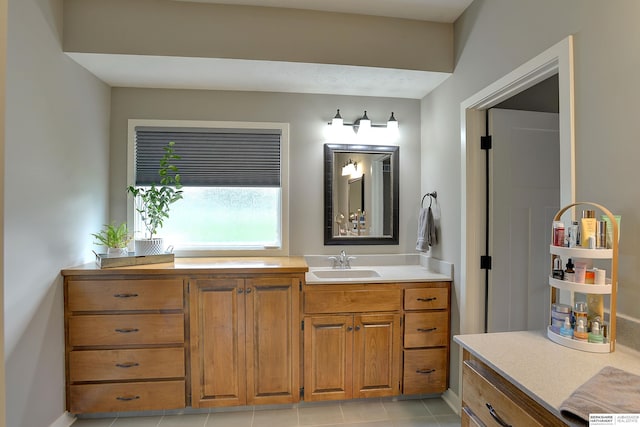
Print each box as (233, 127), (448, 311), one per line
(303, 282), (450, 401)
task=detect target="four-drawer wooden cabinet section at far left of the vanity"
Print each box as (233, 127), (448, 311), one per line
(64, 276), (186, 413)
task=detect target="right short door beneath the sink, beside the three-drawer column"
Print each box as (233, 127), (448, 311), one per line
(353, 314), (401, 398)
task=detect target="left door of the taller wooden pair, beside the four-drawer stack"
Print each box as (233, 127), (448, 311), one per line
(189, 279), (246, 408)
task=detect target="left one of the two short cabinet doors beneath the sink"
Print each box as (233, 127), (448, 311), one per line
(304, 315), (353, 401)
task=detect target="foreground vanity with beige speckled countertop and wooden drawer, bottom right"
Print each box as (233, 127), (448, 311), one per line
(454, 331), (640, 426)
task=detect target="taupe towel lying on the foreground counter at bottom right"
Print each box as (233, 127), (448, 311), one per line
(560, 366), (640, 426)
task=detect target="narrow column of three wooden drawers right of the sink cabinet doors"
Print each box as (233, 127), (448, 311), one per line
(402, 282), (451, 394)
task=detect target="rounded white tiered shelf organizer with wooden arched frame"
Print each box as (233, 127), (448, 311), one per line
(547, 202), (619, 353)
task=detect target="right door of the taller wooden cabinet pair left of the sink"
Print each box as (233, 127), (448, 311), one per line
(245, 277), (300, 405)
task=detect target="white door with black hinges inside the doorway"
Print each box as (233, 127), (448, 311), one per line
(487, 109), (560, 332)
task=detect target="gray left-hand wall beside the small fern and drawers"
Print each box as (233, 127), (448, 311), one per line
(3, 0), (110, 427)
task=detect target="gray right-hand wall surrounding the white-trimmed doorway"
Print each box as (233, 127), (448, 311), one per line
(421, 0), (640, 398)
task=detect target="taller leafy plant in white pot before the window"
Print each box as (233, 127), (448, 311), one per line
(127, 141), (182, 255)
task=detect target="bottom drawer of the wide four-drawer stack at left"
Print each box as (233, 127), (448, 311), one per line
(69, 380), (186, 414)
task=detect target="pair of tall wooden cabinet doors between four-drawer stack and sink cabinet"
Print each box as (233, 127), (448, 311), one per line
(189, 275), (302, 408)
